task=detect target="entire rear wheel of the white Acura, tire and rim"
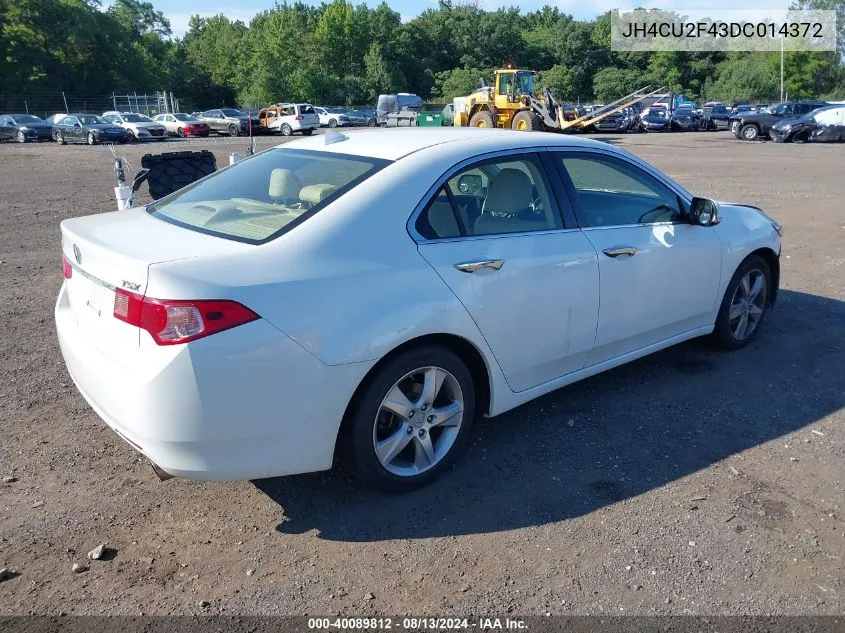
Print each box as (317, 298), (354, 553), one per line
(345, 346), (475, 493)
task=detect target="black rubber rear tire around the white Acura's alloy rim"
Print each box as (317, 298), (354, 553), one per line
(343, 346), (475, 493)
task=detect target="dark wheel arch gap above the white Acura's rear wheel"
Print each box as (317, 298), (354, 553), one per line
(335, 333), (492, 452)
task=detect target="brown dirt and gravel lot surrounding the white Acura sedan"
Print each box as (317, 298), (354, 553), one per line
(0, 130), (845, 615)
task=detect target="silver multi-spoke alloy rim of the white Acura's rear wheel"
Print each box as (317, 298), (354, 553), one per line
(373, 367), (464, 477)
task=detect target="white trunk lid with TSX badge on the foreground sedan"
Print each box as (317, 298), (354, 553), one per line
(61, 208), (249, 365)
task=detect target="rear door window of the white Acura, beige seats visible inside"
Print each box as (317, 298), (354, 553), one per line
(416, 154), (562, 239)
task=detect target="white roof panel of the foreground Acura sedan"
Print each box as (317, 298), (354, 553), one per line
(282, 127), (613, 160)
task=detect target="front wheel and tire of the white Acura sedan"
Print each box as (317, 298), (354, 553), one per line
(710, 255), (772, 350)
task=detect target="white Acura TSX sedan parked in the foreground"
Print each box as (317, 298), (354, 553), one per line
(55, 128), (782, 491)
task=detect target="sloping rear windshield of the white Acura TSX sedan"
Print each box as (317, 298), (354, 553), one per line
(147, 148), (389, 244)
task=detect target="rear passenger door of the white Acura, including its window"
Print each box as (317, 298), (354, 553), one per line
(409, 152), (599, 391)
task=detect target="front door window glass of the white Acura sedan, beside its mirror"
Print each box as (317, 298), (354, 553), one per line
(557, 152), (684, 228)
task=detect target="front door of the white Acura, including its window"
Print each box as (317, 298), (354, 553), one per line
(552, 149), (722, 365)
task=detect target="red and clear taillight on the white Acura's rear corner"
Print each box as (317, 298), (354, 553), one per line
(114, 289), (259, 345)
